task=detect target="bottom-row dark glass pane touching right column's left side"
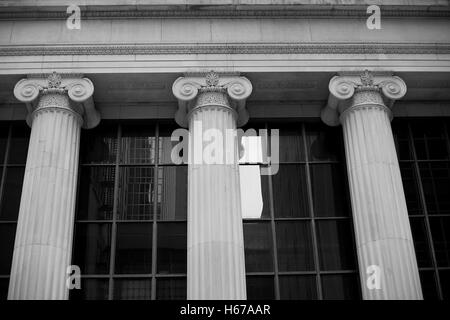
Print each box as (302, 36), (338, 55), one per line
(321, 274), (361, 300)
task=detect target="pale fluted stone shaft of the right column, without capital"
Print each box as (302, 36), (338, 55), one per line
(341, 93), (422, 299)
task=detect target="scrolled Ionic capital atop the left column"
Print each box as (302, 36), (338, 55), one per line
(14, 72), (101, 129)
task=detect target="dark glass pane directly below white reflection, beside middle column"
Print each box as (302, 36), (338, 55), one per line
(244, 222), (273, 272)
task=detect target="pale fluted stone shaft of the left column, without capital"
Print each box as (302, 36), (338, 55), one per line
(8, 94), (81, 299)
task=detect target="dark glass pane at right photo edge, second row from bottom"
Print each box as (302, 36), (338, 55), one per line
(430, 217), (450, 267)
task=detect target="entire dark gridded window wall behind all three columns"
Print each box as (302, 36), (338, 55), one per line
(0, 119), (450, 299)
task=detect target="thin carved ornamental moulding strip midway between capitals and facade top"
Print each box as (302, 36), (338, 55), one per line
(0, 43), (450, 56)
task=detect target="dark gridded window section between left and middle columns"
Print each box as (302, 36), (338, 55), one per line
(70, 121), (187, 300)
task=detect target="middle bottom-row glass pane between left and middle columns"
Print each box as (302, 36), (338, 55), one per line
(114, 279), (152, 300)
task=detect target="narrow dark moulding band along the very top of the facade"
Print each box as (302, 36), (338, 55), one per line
(0, 6), (450, 20)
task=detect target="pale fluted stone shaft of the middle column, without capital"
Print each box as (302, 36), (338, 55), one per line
(187, 100), (246, 299)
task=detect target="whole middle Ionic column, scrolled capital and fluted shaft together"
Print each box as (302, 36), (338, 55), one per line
(173, 72), (252, 299)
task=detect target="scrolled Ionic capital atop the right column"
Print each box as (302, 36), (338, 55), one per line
(321, 70), (406, 126)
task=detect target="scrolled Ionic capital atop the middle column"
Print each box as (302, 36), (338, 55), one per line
(172, 71), (253, 127)
